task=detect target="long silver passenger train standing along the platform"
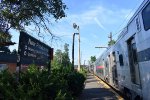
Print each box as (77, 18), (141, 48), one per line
(91, 0), (150, 100)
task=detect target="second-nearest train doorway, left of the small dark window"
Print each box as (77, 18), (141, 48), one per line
(112, 52), (118, 87)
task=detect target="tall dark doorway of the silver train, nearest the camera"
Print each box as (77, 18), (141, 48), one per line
(127, 36), (140, 85)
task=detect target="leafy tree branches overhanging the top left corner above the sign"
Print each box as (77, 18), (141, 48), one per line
(0, 0), (66, 35)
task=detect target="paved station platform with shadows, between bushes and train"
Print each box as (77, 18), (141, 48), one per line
(78, 73), (123, 100)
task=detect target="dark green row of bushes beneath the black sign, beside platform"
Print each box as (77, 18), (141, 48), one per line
(0, 65), (85, 100)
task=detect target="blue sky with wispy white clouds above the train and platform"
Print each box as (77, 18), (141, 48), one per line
(10, 0), (143, 64)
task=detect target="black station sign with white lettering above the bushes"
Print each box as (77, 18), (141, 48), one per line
(18, 32), (53, 66)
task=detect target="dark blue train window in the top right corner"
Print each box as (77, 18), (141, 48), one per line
(142, 3), (150, 31)
